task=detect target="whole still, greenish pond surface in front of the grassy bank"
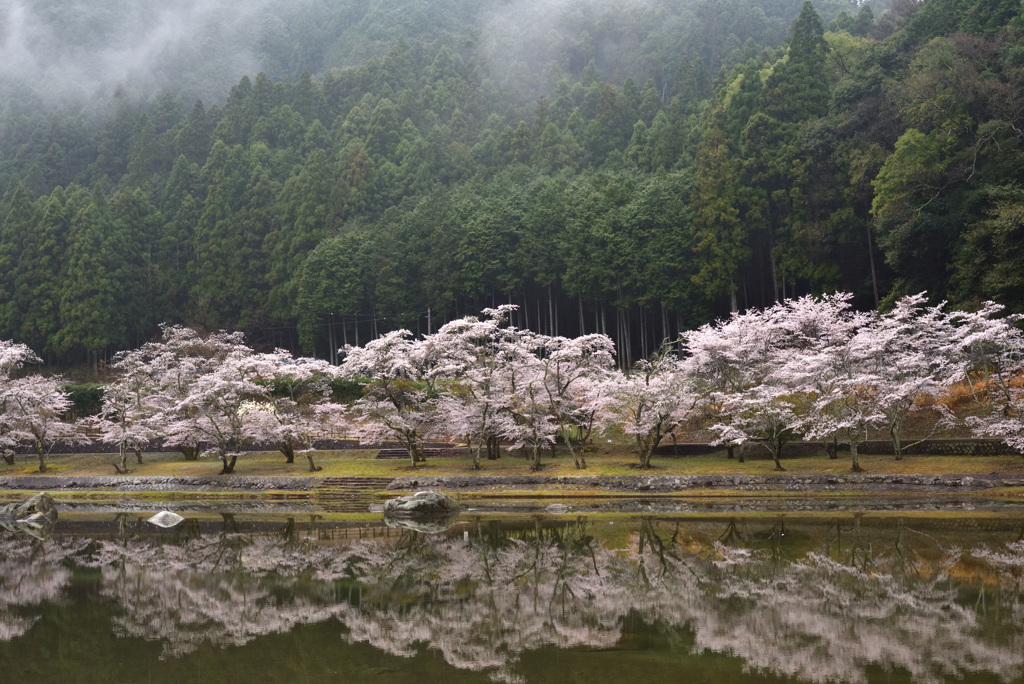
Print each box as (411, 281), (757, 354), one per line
(0, 507), (1024, 684)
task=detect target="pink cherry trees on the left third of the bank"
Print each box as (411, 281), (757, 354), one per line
(0, 326), (344, 473)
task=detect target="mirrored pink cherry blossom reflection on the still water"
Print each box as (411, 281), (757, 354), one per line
(0, 514), (1024, 683)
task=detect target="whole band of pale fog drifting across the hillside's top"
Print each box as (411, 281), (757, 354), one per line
(0, 0), (800, 107)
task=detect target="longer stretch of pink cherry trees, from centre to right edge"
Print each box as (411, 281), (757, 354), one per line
(342, 294), (1024, 471)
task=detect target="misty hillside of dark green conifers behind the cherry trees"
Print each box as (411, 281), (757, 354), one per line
(0, 0), (1024, 364)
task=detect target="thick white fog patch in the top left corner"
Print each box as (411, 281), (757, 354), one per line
(0, 0), (269, 102)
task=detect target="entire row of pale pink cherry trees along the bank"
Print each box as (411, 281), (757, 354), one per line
(0, 294), (1024, 473)
